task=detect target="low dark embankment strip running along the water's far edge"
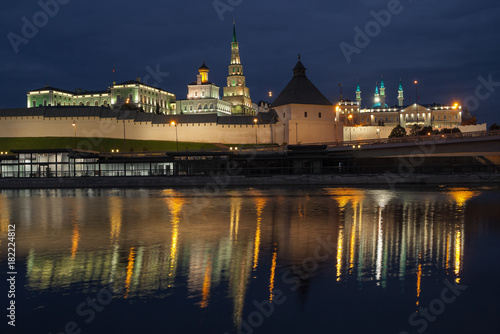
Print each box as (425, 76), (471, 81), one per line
(0, 173), (500, 189)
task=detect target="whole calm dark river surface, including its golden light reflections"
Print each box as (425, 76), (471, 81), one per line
(0, 187), (500, 334)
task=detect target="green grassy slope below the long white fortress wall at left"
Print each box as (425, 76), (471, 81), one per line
(0, 137), (218, 152)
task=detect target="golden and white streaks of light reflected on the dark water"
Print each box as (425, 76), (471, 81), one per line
(0, 188), (481, 325)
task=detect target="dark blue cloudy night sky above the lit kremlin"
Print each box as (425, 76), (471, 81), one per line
(0, 0), (500, 126)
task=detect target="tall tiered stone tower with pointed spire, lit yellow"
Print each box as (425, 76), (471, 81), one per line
(222, 22), (255, 115)
